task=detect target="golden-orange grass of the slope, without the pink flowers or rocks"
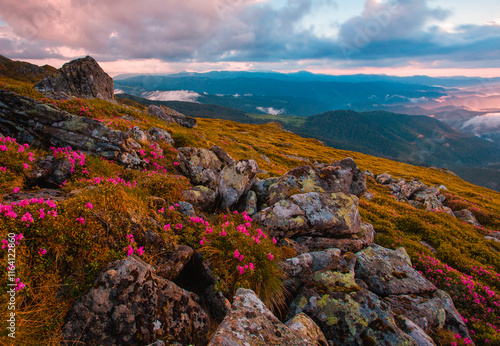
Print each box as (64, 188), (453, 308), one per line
(0, 78), (500, 345)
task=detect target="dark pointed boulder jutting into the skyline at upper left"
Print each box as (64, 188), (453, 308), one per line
(35, 56), (116, 102)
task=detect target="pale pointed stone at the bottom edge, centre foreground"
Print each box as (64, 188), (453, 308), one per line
(208, 288), (324, 346)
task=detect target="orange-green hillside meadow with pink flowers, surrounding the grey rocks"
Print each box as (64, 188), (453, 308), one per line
(0, 77), (500, 345)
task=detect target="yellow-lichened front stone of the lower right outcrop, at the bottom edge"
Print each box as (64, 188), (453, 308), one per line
(289, 280), (417, 345)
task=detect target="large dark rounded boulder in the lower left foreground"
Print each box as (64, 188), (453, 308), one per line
(62, 256), (211, 345)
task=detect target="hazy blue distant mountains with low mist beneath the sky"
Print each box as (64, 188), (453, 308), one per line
(115, 71), (500, 148)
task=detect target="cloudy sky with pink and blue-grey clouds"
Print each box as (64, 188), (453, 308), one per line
(0, 0), (500, 76)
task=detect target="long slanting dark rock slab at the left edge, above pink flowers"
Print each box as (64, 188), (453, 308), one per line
(0, 90), (141, 166)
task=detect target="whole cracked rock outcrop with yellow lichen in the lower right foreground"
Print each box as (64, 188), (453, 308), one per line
(282, 245), (470, 345)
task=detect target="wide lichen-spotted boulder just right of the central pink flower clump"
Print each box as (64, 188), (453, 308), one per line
(254, 192), (361, 238)
